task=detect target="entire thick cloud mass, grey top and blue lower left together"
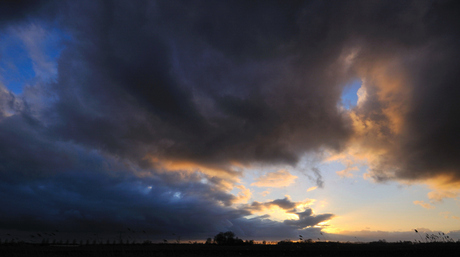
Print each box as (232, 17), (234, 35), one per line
(0, 1), (460, 239)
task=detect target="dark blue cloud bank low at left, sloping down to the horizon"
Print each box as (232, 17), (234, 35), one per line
(0, 87), (328, 240)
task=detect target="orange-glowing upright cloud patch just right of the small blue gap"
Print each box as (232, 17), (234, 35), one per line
(338, 59), (410, 180)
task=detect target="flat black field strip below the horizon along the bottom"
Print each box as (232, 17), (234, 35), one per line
(0, 243), (460, 257)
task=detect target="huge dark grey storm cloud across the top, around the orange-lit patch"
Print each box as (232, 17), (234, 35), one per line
(5, 1), (459, 182)
